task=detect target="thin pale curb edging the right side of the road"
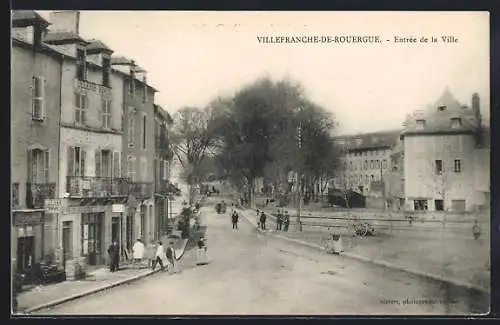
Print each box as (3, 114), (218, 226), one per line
(237, 211), (490, 294)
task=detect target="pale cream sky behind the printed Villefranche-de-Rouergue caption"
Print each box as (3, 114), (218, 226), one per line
(40, 11), (490, 134)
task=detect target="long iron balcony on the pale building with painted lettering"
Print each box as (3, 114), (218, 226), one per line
(66, 176), (129, 198)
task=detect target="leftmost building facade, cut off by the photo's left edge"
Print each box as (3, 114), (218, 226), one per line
(11, 11), (63, 272)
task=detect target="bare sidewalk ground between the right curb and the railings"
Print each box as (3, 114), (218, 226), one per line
(237, 210), (490, 291)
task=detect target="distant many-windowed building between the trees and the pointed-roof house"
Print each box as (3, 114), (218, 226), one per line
(333, 131), (400, 196)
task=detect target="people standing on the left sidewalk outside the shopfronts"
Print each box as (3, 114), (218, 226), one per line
(108, 239), (181, 272)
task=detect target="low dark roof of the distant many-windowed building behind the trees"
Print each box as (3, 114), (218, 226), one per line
(334, 130), (401, 151)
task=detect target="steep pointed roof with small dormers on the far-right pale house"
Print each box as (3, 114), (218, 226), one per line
(402, 88), (478, 136)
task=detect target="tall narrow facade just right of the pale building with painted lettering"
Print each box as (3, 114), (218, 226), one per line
(111, 57), (158, 249)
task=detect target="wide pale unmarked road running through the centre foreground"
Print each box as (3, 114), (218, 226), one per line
(39, 207), (488, 315)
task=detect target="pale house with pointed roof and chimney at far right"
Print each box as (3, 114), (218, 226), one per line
(402, 89), (490, 212)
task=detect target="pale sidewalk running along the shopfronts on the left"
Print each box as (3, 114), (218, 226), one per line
(17, 239), (189, 314)
